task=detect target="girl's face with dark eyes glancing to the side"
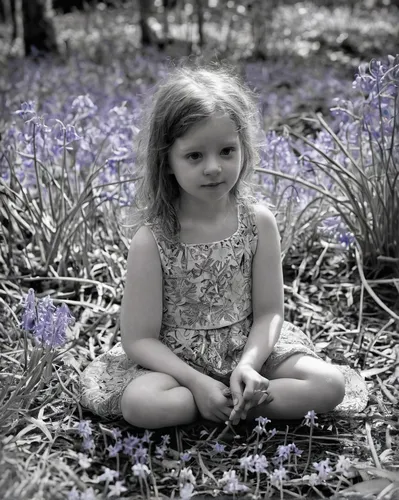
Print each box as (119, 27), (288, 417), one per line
(168, 113), (242, 203)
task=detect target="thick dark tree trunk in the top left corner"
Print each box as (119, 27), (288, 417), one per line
(21, 0), (59, 55)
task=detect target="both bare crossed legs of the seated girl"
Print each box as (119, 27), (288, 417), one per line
(121, 354), (345, 429)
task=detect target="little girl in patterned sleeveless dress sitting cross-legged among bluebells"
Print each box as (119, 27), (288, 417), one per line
(81, 64), (367, 429)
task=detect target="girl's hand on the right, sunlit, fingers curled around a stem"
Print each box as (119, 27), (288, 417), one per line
(230, 364), (273, 424)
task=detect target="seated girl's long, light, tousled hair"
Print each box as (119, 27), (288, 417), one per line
(127, 65), (261, 242)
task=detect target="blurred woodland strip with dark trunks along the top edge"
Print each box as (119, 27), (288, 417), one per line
(0, 0), (399, 66)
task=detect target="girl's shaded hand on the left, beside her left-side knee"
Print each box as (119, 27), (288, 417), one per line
(190, 375), (233, 422)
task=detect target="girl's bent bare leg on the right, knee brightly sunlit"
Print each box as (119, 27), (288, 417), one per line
(246, 354), (345, 420)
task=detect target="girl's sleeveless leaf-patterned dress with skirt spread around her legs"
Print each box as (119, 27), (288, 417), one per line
(80, 199), (367, 419)
